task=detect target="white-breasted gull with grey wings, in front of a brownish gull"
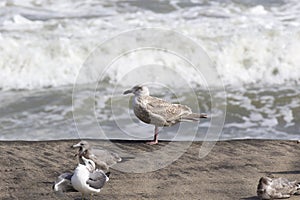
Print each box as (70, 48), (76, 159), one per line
(53, 157), (109, 199)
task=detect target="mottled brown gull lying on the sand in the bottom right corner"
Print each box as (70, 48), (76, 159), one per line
(257, 177), (300, 199)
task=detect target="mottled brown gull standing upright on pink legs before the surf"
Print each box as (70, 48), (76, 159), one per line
(123, 85), (207, 145)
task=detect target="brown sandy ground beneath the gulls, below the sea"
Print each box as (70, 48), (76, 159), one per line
(0, 140), (300, 200)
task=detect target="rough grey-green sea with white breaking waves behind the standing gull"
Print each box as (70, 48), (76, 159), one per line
(0, 0), (300, 140)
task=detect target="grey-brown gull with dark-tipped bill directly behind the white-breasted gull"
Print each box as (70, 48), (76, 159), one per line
(72, 141), (122, 172)
